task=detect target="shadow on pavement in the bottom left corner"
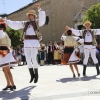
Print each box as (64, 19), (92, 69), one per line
(0, 86), (36, 100)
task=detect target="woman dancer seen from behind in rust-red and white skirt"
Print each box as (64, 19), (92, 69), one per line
(61, 30), (84, 78)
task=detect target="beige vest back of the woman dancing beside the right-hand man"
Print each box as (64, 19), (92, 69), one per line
(64, 36), (78, 47)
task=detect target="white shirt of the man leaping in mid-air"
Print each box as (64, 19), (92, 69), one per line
(5, 9), (46, 47)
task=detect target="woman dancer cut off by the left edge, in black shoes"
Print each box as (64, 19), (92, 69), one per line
(0, 23), (16, 90)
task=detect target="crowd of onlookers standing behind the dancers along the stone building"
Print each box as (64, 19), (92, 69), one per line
(11, 41), (100, 66)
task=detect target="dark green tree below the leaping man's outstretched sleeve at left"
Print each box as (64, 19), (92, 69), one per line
(7, 28), (22, 48)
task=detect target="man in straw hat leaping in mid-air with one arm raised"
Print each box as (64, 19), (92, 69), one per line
(0, 4), (46, 83)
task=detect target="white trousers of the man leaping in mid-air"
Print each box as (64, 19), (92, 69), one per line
(24, 48), (39, 68)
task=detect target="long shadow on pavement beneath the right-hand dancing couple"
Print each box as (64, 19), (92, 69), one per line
(56, 75), (100, 83)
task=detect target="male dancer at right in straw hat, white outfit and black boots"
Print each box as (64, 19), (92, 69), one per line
(66, 20), (100, 76)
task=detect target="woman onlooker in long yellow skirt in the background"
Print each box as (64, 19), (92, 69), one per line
(54, 41), (61, 64)
